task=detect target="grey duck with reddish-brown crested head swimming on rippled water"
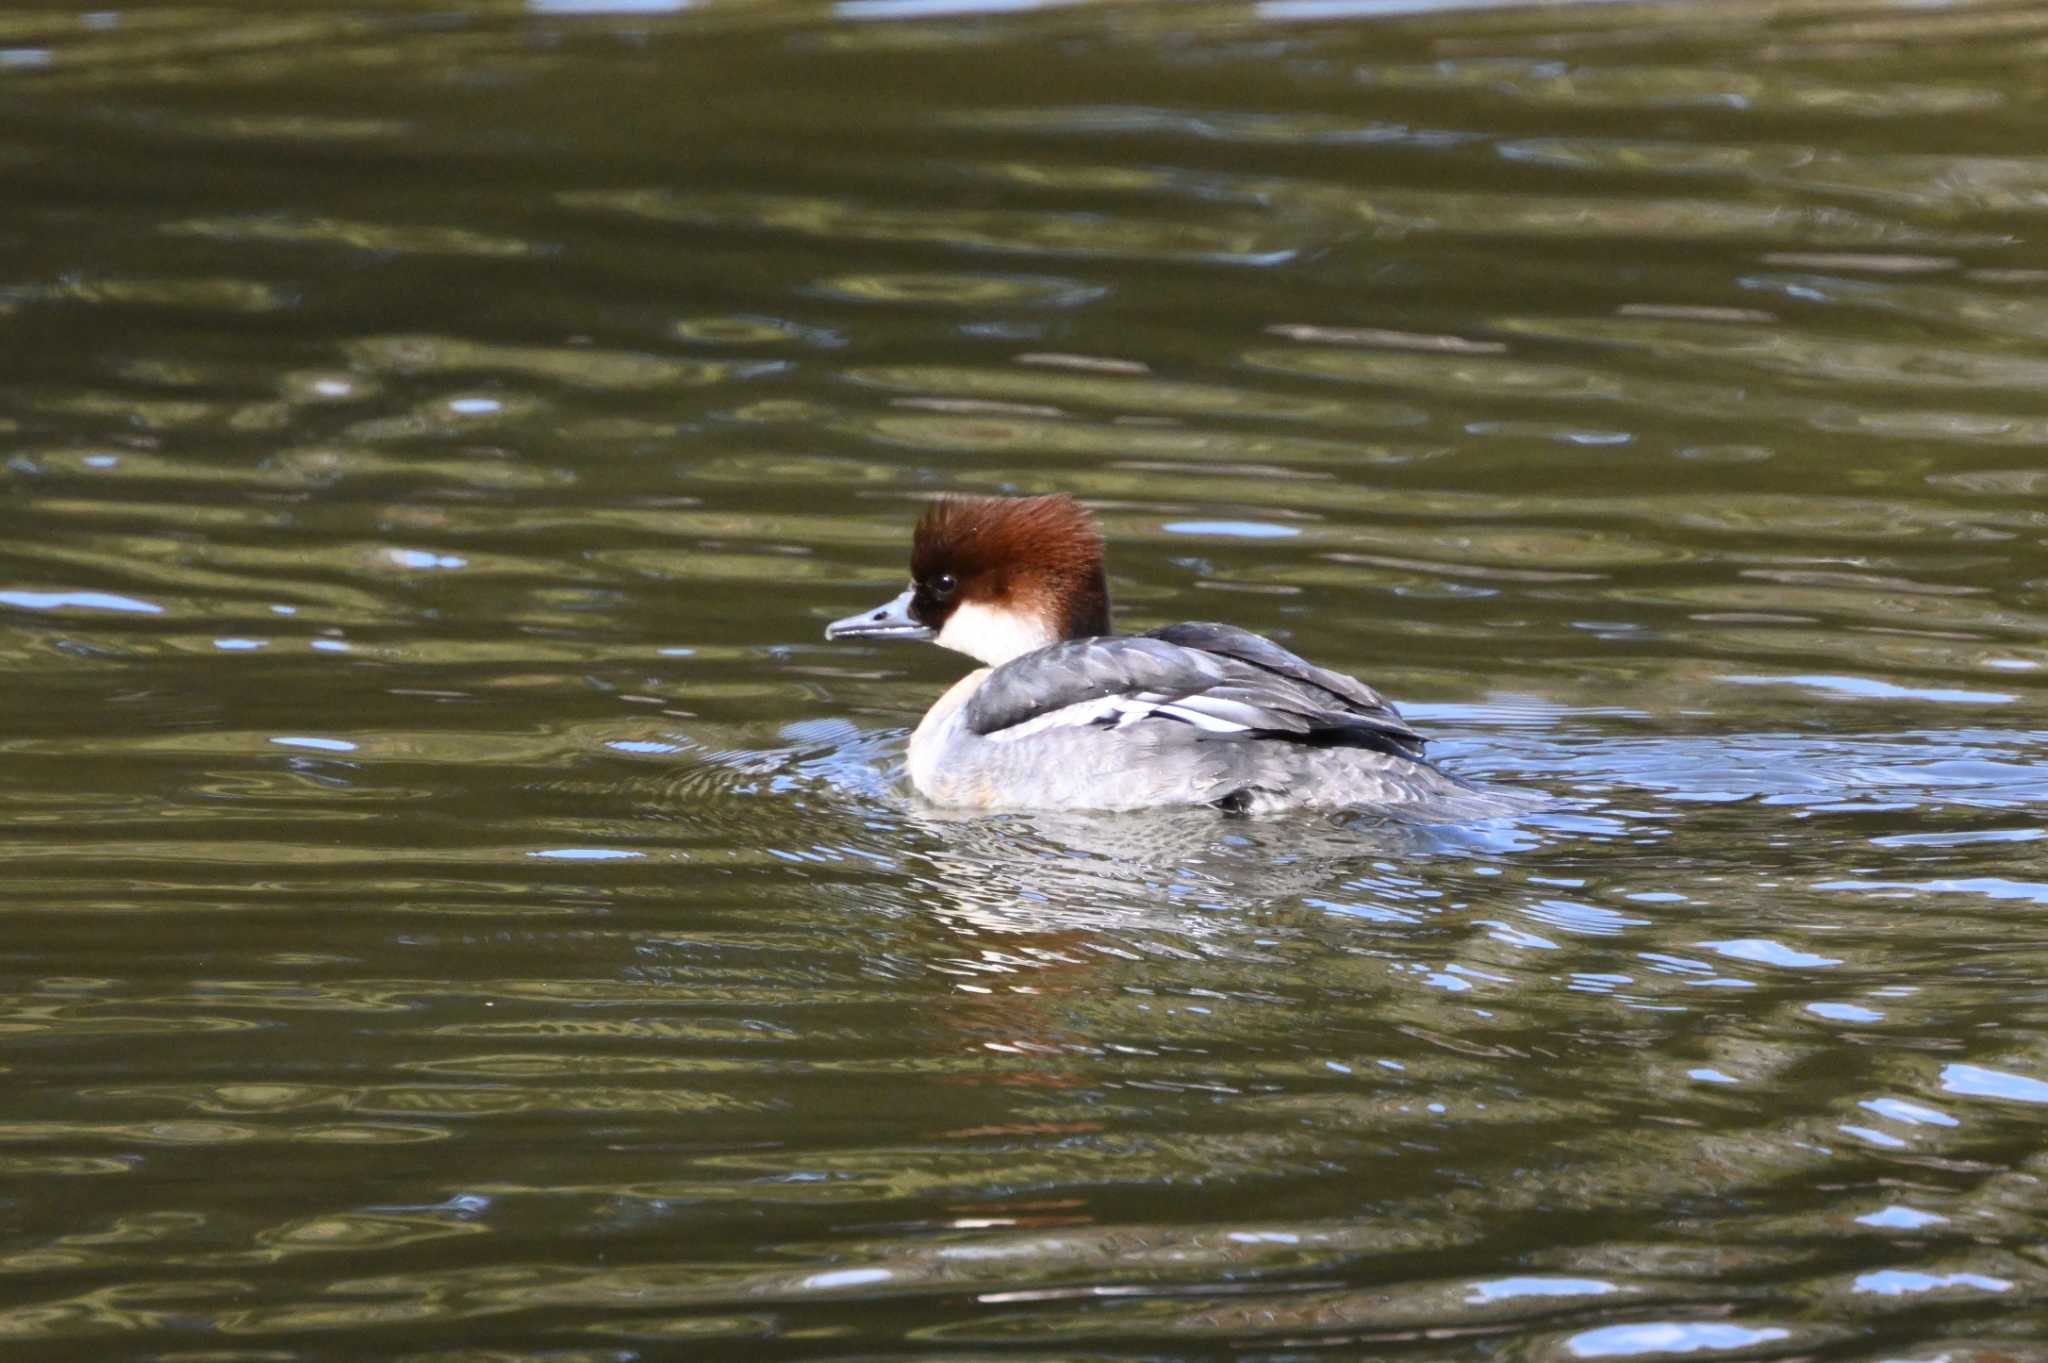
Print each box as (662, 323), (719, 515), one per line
(825, 493), (1524, 823)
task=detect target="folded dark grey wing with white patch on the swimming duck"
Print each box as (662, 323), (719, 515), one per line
(965, 624), (1423, 757)
